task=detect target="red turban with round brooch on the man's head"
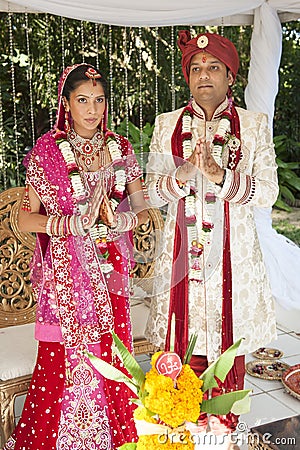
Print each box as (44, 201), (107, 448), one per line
(177, 30), (239, 84)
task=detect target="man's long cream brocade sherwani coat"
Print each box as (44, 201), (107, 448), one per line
(146, 102), (278, 361)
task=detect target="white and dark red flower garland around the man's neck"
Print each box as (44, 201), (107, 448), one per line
(181, 101), (239, 282)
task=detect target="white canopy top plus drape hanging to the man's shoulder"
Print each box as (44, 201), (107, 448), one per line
(0, 0), (300, 125)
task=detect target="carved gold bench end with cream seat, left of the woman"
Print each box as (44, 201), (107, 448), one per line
(0, 188), (37, 446)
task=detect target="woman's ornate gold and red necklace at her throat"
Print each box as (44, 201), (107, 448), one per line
(68, 130), (105, 171)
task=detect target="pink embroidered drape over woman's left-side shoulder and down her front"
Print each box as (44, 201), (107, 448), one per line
(27, 133), (113, 347)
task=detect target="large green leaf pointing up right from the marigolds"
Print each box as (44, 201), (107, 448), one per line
(199, 338), (243, 392)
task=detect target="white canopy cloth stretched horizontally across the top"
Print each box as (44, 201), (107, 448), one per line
(0, 0), (300, 27)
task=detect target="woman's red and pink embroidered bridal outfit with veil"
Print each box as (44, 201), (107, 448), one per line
(5, 66), (141, 450)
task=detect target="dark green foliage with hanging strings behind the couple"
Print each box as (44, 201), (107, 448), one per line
(0, 13), (300, 199)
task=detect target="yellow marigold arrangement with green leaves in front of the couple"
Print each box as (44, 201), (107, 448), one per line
(88, 333), (251, 450)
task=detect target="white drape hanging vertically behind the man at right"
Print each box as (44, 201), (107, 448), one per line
(245, 2), (300, 312)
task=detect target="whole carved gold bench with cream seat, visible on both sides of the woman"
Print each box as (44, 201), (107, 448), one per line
(0, 187), (163, 448)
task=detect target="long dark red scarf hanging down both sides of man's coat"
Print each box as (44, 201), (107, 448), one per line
(166, 100), (240, 388)
